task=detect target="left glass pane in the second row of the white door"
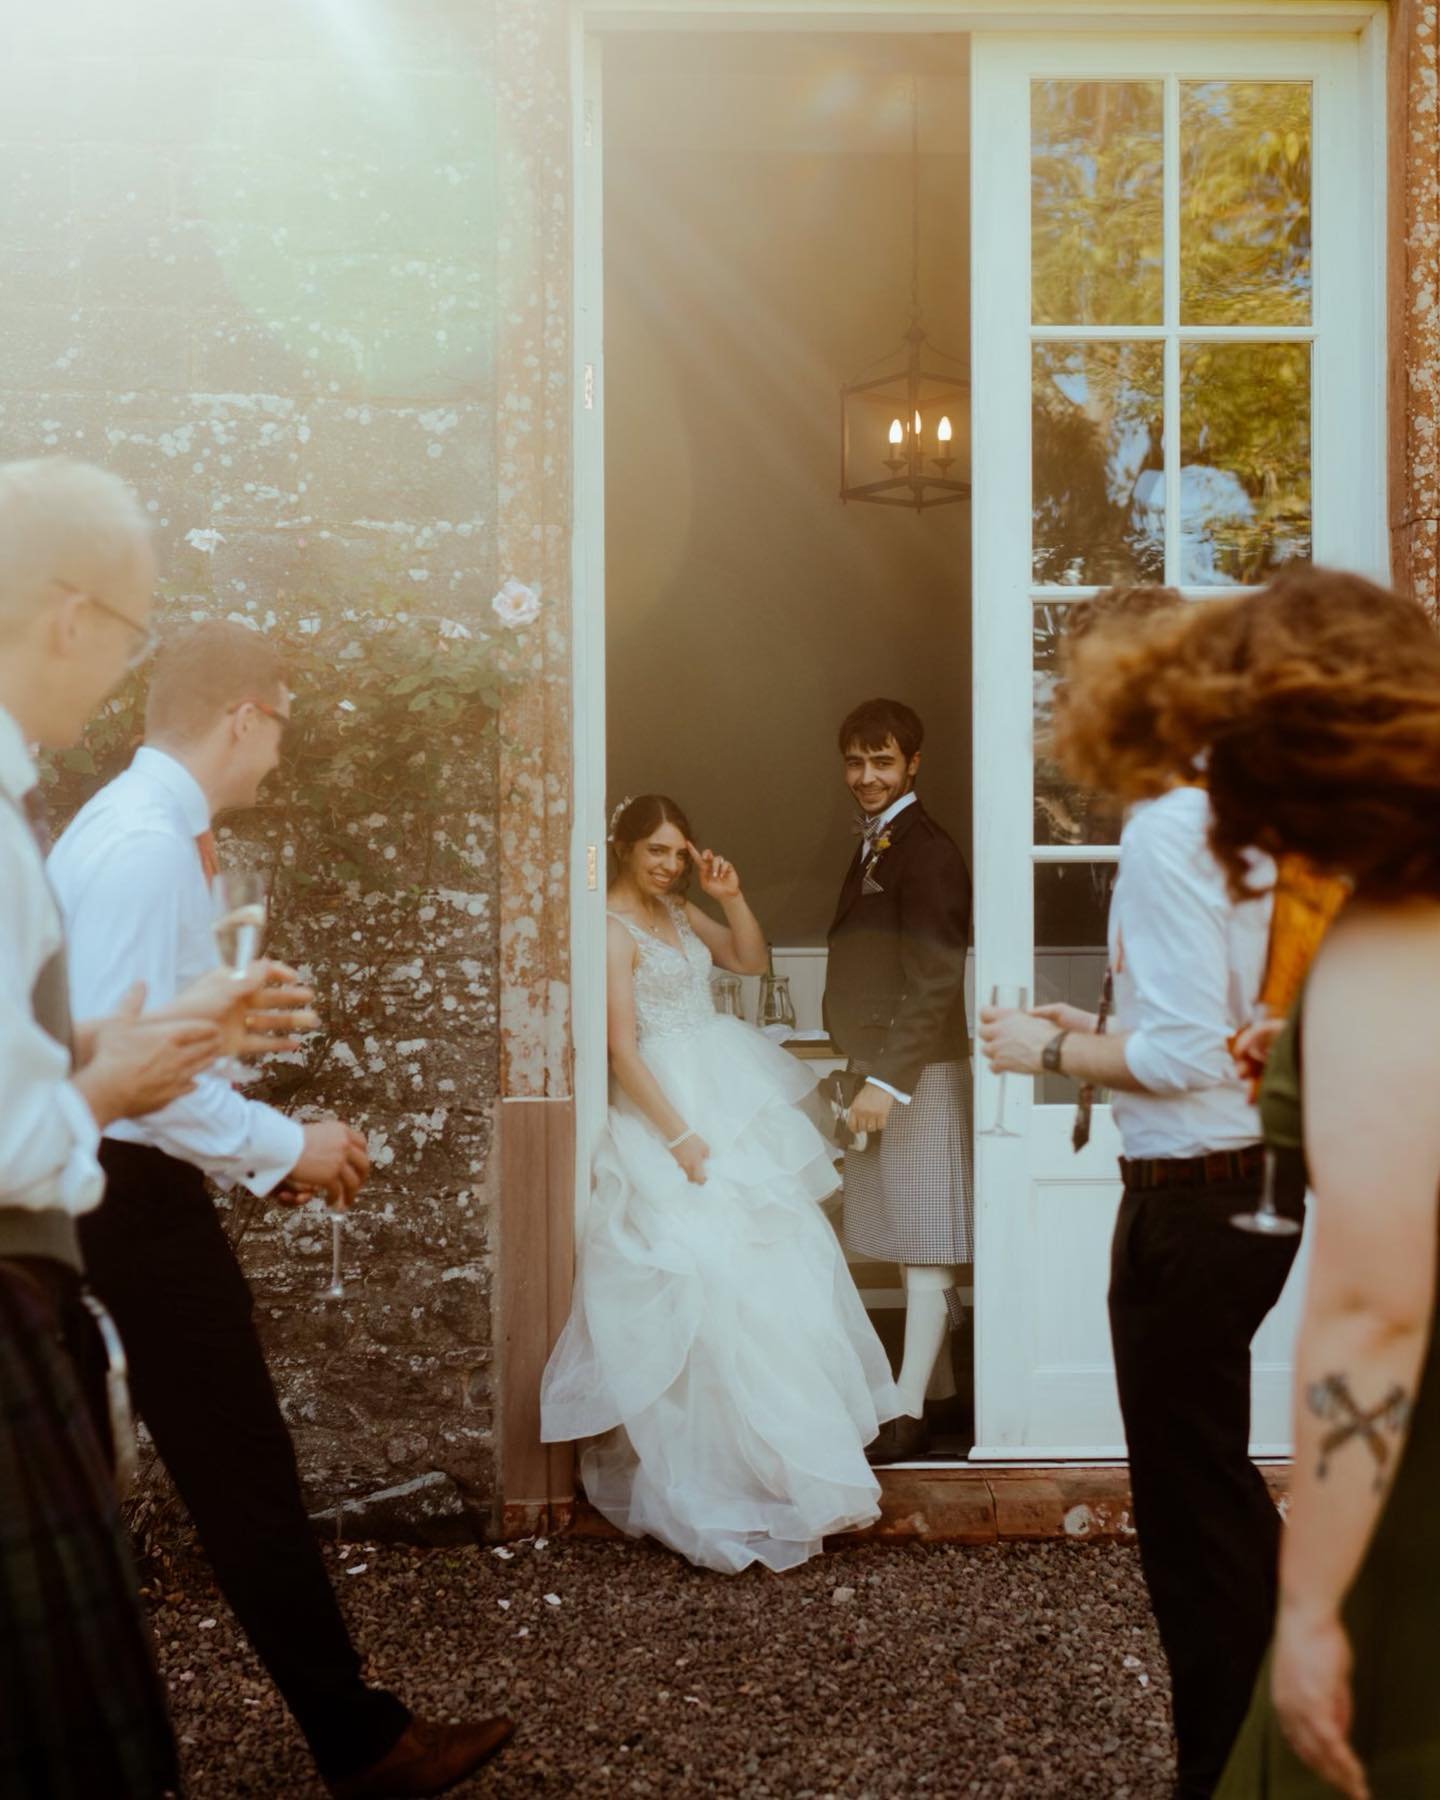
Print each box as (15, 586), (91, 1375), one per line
(1031, 344), (1165, 587)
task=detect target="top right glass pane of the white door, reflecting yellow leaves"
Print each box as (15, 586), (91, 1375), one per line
(1181, 81), (1310, 324)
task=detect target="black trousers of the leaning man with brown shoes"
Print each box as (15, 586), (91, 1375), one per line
(81, 1139), (410, 1778)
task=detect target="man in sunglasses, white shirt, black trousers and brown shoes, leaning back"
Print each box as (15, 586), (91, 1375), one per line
(50, 623), (513, 1800)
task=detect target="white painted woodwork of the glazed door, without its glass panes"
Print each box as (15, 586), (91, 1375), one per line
(970, 32), (1386, 1462)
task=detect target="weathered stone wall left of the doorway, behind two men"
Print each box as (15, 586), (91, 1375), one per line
(0, 0), (518, 1533)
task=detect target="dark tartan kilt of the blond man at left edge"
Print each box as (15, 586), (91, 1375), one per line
(0, 1264), (180, 1800)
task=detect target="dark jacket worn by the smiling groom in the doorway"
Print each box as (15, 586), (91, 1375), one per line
(824, 801), (970, 1094)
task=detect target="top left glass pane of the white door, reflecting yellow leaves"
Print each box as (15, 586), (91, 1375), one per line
(1030, 81), (1165, 326)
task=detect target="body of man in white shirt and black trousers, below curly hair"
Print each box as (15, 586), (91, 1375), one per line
(979, 590), (1305, 1800)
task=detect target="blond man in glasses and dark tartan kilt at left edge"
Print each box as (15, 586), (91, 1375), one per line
(0, 459), (229, 1800)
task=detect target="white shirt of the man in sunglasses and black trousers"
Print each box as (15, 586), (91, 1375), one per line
(50, 747), (304, 1193)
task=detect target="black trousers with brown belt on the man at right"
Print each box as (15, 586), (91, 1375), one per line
(1111, 1170), (1305, 1800)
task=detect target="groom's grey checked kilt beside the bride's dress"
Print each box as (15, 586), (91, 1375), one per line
(844, 1060), (976, 1264)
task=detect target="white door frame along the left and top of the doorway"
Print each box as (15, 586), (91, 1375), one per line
(571, 0), (1388, 1432)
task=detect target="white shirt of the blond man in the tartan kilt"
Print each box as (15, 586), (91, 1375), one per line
(0, 707), (104, 1213)
